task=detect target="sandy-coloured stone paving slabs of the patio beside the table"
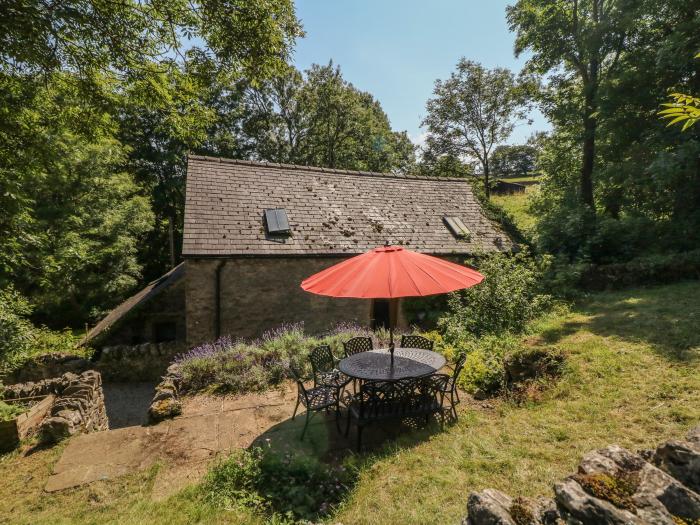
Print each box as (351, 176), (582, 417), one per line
(45, 378), (460, 500)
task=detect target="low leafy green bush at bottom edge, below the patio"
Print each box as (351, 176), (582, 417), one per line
(202, 448), (355, 523)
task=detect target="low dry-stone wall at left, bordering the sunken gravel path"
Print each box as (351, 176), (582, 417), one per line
(3, 370), (109, 443)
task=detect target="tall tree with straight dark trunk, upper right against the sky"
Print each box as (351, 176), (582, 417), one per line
(507, 0), (638, 213)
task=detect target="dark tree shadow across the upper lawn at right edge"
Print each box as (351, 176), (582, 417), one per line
(539, 281), (700, 363)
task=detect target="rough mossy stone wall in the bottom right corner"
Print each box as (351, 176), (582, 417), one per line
(462, 426), (700, 525)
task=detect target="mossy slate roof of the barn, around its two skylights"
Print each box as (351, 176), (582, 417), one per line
(182, 155), (513, 257)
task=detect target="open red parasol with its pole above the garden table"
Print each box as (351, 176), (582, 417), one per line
(301, 246), (484, 362)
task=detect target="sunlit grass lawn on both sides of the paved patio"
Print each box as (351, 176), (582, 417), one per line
(0, 282), (700, 525)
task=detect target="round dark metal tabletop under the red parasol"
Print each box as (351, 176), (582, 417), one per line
(338, 348), (445, 381)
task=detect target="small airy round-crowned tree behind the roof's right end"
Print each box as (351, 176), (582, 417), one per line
(423, 58), (525, 197)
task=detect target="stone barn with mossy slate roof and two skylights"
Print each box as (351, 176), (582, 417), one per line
(86, 155), (513, 345)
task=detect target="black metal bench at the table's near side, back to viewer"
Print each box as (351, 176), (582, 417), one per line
(345, 375), (447, 452)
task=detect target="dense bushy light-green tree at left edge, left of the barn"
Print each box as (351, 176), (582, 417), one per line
(0, 73), (153, 327)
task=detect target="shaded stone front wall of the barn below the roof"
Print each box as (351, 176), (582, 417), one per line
(185, 257), (371, 346)
